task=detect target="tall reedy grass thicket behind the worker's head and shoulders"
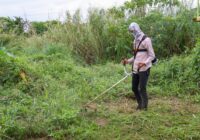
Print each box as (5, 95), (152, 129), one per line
(36, 6), (200, 64)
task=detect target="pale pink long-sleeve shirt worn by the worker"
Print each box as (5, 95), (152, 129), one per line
(128, 36), (155, 73)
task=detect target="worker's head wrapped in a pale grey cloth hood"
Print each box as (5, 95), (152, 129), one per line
(128, 22), (144, 39)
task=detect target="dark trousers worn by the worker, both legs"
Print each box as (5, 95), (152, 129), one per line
(132, 68), (150, 109)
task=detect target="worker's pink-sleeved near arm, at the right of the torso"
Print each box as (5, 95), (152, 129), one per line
(144, 38), (155, 65)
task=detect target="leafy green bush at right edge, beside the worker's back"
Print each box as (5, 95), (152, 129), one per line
(150, 38), (200, 98)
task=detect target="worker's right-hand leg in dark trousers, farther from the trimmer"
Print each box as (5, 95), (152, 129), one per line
(139, 69), (150, 109)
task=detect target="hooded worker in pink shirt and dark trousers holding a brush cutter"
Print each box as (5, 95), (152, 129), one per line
(122, 22), (155, 110)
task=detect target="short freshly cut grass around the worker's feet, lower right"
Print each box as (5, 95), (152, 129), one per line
(80, 96), (200, 139)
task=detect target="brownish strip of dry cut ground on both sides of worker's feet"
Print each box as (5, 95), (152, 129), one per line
(103, 96), (200, 114)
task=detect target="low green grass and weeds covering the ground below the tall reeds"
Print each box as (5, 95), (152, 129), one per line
(0, 37), (200, 140)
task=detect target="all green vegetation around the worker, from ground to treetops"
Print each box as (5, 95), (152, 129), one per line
(0, 0), (200, 140)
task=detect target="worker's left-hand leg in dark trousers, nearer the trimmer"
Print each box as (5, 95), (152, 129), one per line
(132, 74), (142, 109)
